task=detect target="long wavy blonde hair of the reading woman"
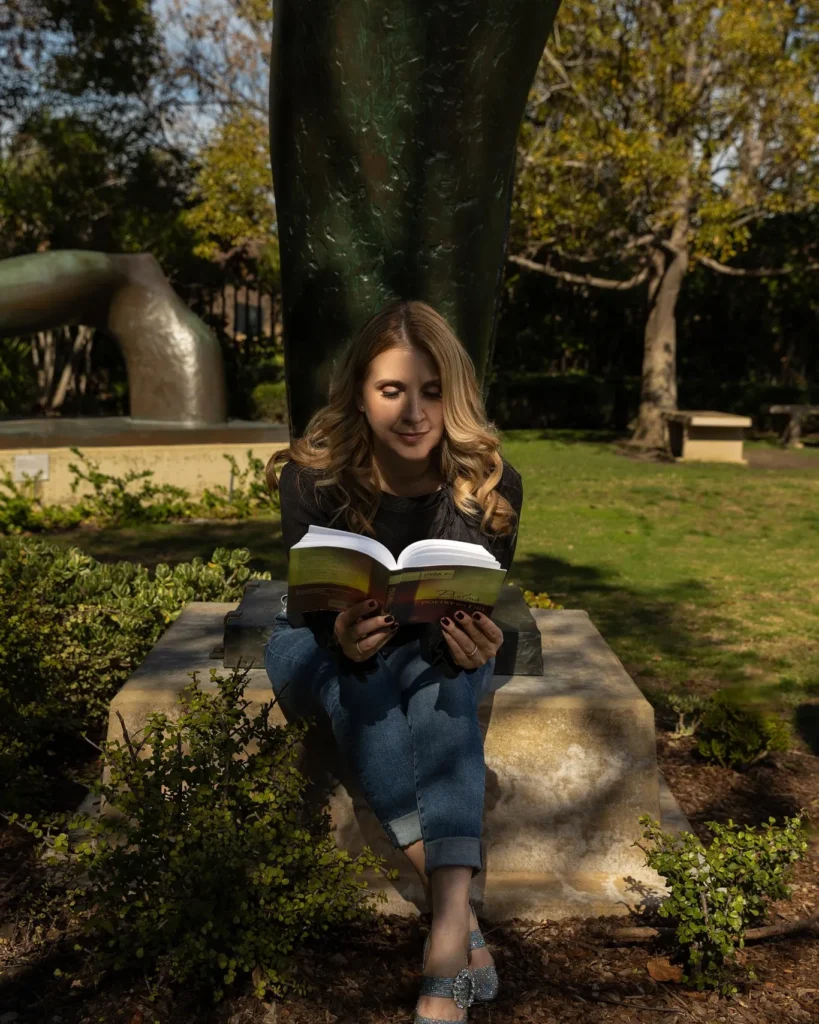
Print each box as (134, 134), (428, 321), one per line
(266, 299), (516, 536)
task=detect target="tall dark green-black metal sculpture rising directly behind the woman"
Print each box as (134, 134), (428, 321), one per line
(270, 0), (559, 436)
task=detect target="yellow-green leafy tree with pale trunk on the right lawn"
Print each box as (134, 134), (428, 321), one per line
(510, 0), (819, 446)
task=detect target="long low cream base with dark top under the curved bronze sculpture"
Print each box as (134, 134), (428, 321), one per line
(0, 417), (290, 505)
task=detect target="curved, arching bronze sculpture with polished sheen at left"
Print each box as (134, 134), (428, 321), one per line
(0, 250), (227, 426)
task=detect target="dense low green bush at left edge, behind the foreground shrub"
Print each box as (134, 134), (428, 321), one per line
(0, 539), (269, 800)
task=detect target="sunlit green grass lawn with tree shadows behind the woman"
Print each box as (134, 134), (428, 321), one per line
(35, 431), (819, 703)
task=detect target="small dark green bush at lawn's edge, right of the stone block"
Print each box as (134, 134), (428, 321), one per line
(697, 692), (790, 771)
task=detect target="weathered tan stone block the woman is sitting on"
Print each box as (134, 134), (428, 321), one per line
(109, 602), (688, 921)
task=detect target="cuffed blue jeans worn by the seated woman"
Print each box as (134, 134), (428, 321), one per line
(264, 611), (495, 873)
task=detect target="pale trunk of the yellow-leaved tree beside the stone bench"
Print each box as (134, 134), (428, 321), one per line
(632, 239), (688, 449)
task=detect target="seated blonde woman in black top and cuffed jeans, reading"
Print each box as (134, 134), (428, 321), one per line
(265, 301), (523, 1024)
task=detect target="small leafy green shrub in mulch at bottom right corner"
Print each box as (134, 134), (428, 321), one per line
(637, 816), (808, 994)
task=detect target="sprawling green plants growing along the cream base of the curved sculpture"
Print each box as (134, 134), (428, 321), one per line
(0, 447), (278, 536)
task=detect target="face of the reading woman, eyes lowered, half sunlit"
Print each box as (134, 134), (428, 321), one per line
(358, 347), (443, 461)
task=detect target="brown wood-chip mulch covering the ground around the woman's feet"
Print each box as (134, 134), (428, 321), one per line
(0, 734), (819, 1024)
